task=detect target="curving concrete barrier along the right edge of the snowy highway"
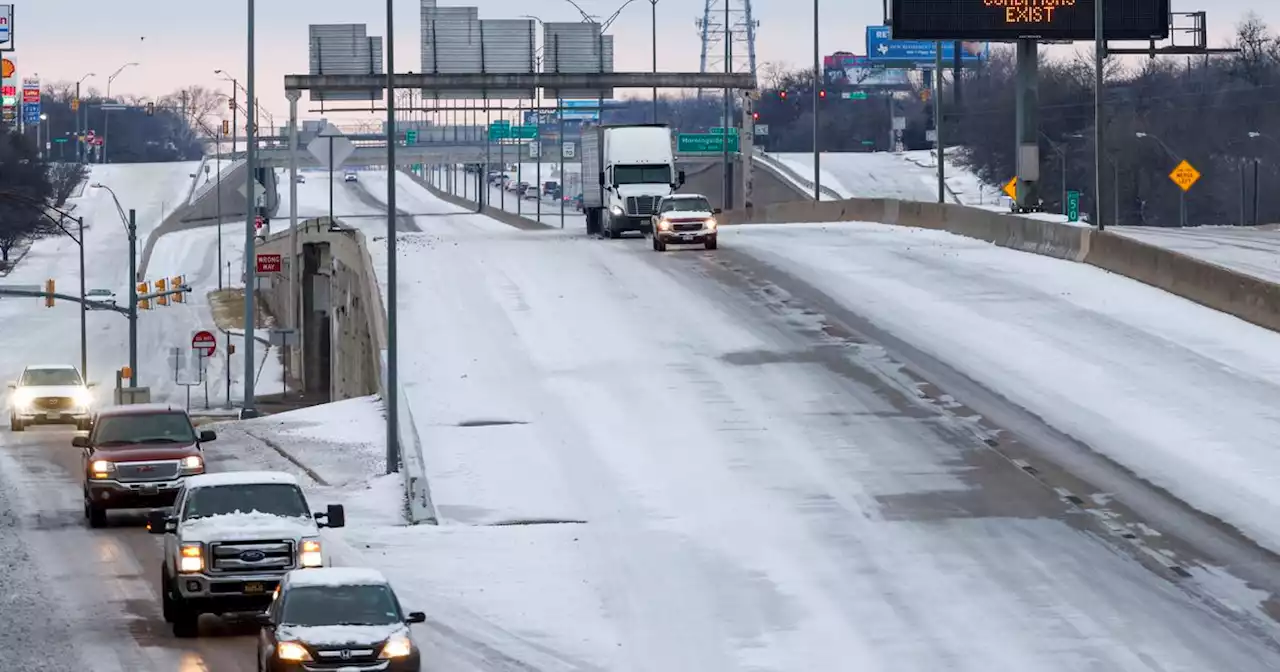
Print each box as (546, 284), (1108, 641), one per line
(721, 198), (1280, 332)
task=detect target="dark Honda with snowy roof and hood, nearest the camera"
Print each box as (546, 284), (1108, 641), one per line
(257, 567), (426, 672)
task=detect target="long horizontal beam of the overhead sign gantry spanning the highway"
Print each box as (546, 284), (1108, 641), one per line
(284, 73), (755, 91)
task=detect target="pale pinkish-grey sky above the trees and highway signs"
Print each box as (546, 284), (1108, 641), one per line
(10, 0), (1280, 118)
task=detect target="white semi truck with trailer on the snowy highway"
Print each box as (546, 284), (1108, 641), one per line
(581, 124), (685, 238)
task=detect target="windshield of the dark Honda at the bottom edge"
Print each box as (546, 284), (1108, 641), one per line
(280, 586), (404, 626)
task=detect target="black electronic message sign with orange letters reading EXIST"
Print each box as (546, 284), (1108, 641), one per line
(891, 0), (1170, 41)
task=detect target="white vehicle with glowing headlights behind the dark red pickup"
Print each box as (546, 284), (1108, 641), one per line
(9, 364), (93, 431)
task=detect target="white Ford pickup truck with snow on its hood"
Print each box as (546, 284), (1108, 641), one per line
(147, 471), (346, 637)
